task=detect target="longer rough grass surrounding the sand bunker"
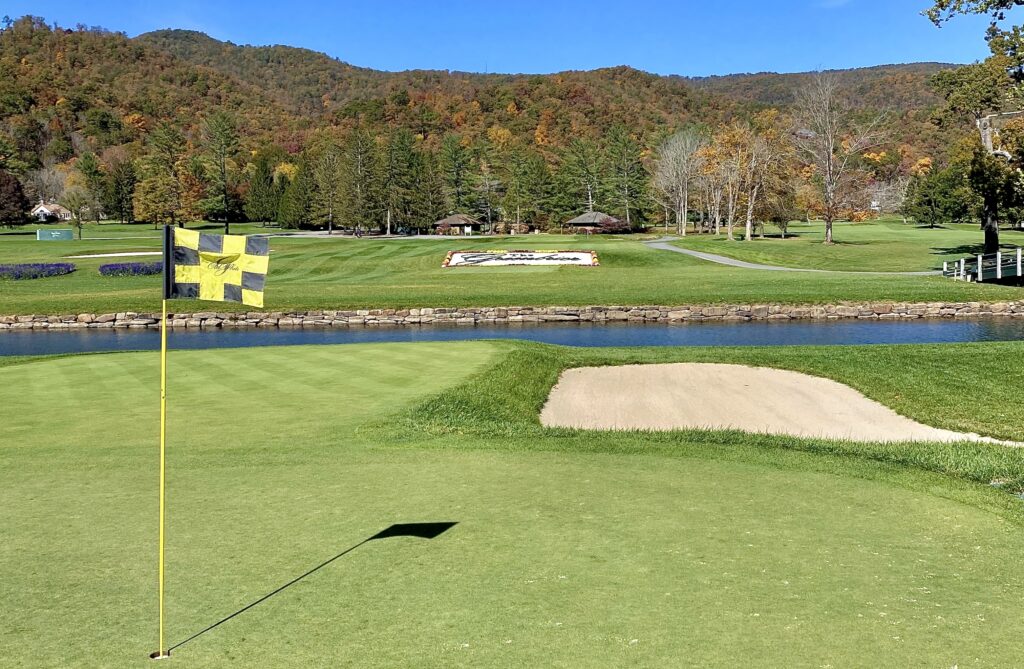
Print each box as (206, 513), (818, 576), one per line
(400, 342), (1024, 493)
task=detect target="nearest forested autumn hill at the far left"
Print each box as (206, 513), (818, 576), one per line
(0, 17), (294, 164)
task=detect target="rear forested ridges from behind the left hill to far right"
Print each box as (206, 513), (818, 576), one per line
(134, 30), (949, 149)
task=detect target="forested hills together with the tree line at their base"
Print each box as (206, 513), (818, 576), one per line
(0, 16), (983, 234)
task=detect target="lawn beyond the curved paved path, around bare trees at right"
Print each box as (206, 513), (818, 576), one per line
(675, 220), (1024, 271)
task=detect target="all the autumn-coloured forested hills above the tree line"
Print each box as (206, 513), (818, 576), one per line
(0, 16), (955, 172)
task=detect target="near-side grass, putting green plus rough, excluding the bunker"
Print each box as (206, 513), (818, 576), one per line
(6, 342), (1024, 667)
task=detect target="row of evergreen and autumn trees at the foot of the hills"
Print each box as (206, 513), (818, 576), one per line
(2, 75), (921, 239)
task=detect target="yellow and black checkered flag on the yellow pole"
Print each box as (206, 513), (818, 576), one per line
(164, 225), (270, 307)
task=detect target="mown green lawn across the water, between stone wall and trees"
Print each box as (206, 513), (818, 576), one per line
(0, 219), (1021, 315)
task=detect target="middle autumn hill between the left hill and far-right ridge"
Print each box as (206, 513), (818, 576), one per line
(134, 30), (716, 145)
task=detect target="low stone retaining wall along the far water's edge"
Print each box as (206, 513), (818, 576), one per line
(0, 300), (1024, 332)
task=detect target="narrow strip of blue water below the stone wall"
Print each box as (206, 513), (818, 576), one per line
(0, 319), (1024, 356)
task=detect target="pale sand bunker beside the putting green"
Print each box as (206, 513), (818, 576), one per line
(541, 363), (1007, 442)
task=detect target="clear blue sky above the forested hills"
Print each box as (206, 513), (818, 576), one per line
(0, 0), (1003, 76)
